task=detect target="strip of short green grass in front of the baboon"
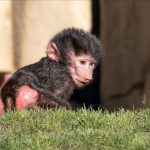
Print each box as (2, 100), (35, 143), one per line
(0, 109), (150, 150)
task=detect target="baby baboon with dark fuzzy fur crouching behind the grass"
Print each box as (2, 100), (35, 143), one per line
(1, 28), (103, 111)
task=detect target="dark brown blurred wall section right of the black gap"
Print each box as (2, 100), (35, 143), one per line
(100, 0), (150, 109)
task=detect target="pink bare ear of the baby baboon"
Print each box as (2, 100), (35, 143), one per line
(47, 42), (60, 62)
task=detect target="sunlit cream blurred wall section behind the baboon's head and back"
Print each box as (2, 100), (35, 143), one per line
(0, 0), (91, 71)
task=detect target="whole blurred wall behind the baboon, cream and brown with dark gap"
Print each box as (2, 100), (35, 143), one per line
(0, 0), (150, 110)
